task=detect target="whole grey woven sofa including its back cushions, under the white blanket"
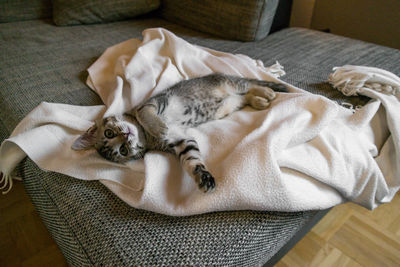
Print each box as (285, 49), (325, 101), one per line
(0, 0), (400, 266)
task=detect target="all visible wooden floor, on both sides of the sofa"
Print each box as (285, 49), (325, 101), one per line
(0, 182), (400, 267)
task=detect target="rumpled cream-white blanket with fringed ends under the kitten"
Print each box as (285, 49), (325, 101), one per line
(0, 28), (400, 216)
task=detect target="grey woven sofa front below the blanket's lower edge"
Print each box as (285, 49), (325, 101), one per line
(18, 161), (314, 266)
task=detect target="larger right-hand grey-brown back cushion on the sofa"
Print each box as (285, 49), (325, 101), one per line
(161, 0), (279, 41)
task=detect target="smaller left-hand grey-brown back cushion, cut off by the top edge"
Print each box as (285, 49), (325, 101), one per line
(53, 0), (160, 26)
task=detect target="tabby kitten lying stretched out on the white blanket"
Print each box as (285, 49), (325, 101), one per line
(72, 73), (287, 192)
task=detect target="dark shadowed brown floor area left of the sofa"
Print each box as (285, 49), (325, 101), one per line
(0, 181), (68, 267)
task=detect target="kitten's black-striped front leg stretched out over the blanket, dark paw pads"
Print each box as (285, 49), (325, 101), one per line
(168, 137), (215, 192)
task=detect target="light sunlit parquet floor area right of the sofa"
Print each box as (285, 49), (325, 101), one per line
(276, 193), (400, 267)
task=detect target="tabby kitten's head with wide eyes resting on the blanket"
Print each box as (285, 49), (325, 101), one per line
(72, 115), (146, 163)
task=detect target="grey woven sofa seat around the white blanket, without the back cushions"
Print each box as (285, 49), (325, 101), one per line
(0, 19), (400, 266)
